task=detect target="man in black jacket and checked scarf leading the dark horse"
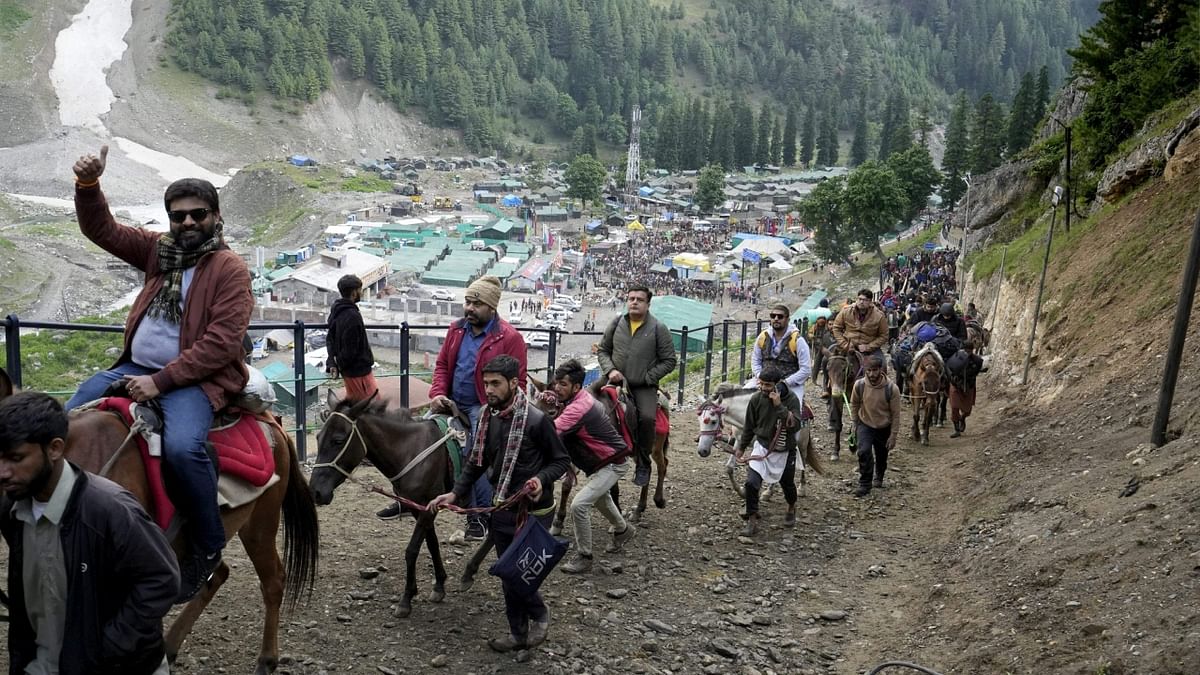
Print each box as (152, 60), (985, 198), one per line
(428, 354), (571, 652)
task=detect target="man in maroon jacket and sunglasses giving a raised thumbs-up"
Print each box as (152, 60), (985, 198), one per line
(67, 145), (254, 602)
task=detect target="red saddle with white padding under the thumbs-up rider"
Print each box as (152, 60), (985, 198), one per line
(95, 396), (278, 530)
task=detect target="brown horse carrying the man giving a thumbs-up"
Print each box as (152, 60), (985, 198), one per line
(0, 369), (319, 675)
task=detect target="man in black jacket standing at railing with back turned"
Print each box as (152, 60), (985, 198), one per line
(325, 274), (379, 401)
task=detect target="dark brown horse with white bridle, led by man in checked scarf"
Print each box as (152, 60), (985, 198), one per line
(310, 395), (458, 619)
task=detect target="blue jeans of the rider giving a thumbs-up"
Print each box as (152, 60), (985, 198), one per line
(66, 363), (226, 554)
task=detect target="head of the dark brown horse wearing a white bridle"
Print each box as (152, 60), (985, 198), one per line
(308, 395), (385, 506)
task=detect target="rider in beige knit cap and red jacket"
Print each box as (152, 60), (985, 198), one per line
(377, 271), (526, 539)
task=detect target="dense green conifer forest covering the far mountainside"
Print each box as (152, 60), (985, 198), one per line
(167, 0), (1096, 154)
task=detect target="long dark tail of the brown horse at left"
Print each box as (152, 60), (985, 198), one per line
(280, 429), (320, 610)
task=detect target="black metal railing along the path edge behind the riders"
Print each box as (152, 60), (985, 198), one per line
(2, 315), (808, 460)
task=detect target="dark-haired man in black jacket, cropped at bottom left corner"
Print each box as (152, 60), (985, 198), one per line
(0, 392), (179, 675)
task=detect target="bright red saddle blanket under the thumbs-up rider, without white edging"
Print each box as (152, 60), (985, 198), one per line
(96, 396), (275, 530)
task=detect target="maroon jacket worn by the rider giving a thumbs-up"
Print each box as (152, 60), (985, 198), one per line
(76, 181), (254, 410)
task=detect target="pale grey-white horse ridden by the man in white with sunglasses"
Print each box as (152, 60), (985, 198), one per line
(696, 386), (824, 498)
